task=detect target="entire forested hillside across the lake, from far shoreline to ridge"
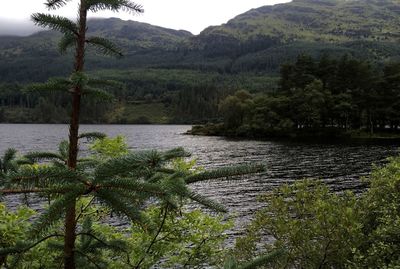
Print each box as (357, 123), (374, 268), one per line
(0, 0), (400, 123)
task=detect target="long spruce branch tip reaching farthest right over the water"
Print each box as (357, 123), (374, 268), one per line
(185, 164), (266, 184)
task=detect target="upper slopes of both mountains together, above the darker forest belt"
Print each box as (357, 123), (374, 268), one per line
(0, 0), (400, 81)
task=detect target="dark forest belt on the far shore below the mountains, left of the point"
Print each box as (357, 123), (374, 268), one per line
(0, 69), (277, 124)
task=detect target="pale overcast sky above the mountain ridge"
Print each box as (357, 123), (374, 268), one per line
(0, 0), (290, 35)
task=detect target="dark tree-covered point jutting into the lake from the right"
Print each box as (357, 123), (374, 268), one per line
(194, 54), (400, 137)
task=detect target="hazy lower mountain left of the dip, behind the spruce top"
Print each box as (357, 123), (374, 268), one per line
(0, 18), (193, 81)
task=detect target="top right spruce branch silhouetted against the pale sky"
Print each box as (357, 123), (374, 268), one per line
(86, 0), (144, 13)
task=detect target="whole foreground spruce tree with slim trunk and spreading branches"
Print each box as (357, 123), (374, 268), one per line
(0, 0), (264, 269)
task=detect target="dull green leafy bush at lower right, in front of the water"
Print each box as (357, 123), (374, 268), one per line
(237, 180), (362, 268)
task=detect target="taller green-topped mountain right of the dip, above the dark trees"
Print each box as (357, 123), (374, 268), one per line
(192, 0), (400, 71)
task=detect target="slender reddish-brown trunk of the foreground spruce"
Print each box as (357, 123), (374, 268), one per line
(64, 0), (87, 269)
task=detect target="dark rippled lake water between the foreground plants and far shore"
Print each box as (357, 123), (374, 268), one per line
(0, 124), (399, 243)
